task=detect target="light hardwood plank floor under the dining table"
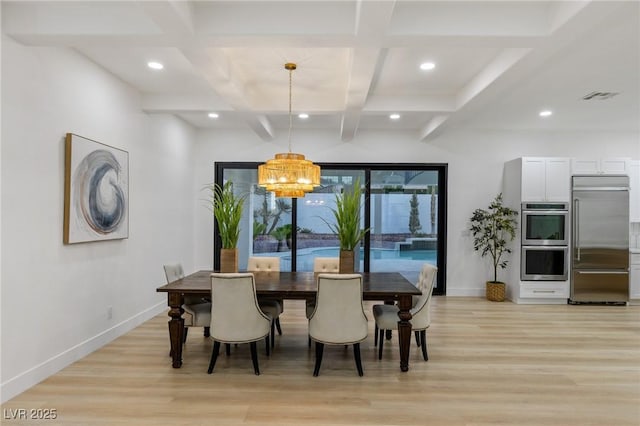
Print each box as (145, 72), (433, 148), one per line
(2, 297), (640, 426)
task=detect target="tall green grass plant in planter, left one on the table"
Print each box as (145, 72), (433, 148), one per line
(206, 181), (246, 272)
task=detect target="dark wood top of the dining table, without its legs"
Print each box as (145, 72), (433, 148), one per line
(156, 271), (421, 300)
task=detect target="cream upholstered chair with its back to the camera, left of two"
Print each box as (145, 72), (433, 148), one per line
(207, 272), (272, 375)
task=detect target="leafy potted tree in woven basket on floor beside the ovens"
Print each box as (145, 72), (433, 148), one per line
(470, 194), (518, 302)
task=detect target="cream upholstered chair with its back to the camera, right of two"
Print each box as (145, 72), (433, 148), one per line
(309, 274), (368, 376)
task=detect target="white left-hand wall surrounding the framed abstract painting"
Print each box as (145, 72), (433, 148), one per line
(1, 37), (196, 401)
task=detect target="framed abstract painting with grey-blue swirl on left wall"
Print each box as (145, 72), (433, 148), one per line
(63, 133), (129, 244)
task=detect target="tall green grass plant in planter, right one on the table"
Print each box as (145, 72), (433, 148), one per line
(327, 179), (369, 274)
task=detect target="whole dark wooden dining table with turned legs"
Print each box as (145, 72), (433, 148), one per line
(156, 270), (421, 371)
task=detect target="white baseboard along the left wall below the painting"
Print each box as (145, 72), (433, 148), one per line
(0, 301), (167, 403)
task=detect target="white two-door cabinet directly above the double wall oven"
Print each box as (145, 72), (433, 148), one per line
(521, 157), (571, 202)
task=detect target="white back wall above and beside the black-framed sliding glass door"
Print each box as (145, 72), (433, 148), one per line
(195, 129), (640, 296)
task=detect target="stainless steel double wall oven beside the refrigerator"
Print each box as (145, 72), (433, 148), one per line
(520, 202), (570, 281)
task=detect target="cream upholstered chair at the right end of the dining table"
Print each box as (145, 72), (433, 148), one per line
(373, 263), (438, 361)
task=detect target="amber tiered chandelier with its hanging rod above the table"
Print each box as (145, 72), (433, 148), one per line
(258, 62), (320, 198)
